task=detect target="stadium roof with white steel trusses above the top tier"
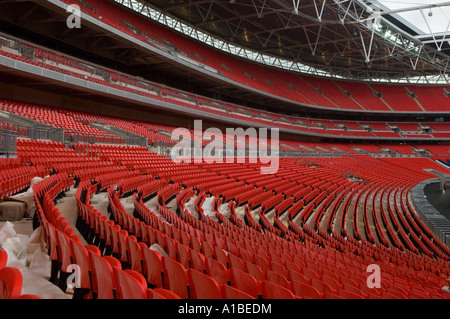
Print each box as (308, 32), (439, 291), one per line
(114, 0), (450, 84)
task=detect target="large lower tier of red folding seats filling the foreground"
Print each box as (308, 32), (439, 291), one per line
(1, 141), (450, 299)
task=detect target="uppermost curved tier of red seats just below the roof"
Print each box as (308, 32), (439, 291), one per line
(55, 0), (450, 112)
